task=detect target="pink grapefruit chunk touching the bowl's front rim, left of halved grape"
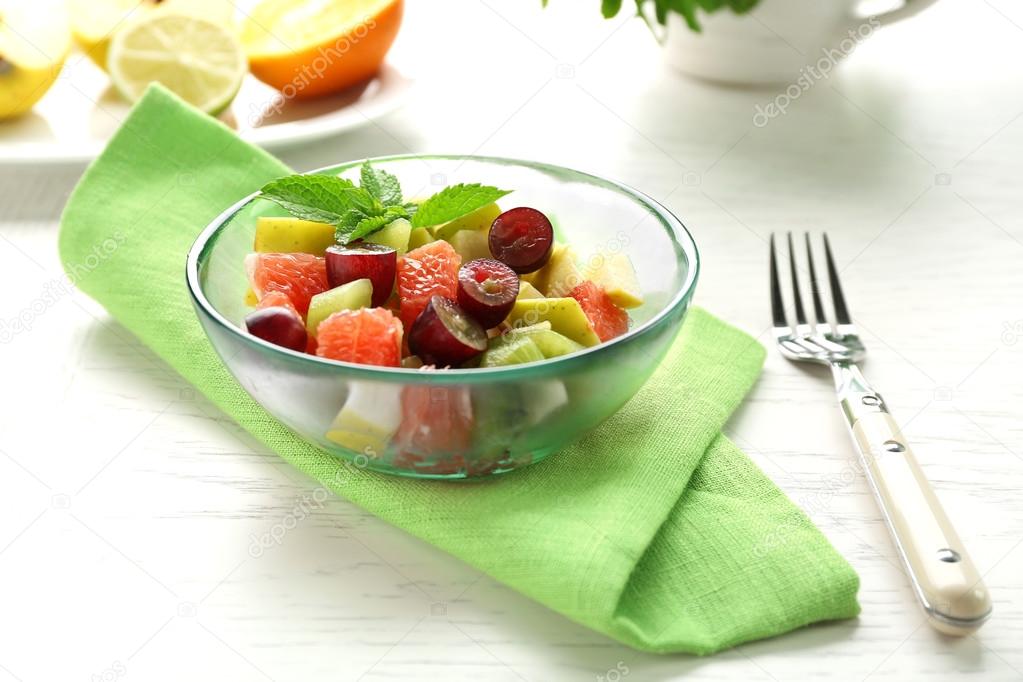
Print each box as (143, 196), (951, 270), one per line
(316, 308), (402, 367)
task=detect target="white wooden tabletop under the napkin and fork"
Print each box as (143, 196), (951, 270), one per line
(0, 0), (1023, 682)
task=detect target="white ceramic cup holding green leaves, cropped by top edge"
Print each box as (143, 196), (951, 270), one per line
(664, 0), (936, 85)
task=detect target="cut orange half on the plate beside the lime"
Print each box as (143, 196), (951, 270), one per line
(241, 0), (403, 99)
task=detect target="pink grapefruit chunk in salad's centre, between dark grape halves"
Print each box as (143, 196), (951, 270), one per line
(398, 241), (461, 328)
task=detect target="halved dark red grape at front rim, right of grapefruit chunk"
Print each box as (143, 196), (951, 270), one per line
(408, 295), (487, 367)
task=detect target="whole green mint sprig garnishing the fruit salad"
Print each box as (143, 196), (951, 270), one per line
(260, 163), (510, 244)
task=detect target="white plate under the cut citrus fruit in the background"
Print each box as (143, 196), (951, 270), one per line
(0, 52), (412, 166)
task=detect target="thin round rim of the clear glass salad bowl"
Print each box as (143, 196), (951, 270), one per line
(185, 154), (700, 383)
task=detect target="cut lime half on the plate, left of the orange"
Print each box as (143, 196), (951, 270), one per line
(106, 13), (249, 113)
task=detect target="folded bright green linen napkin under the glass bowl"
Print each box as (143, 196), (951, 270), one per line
(53, 87), (859, 654)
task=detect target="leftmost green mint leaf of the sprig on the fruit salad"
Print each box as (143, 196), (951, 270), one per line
(260, 175), (374, 225)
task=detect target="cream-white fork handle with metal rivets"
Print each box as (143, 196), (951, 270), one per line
(833, 364), (991, 635)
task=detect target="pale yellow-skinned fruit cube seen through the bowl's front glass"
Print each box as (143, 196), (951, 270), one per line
(326, 381), (401, 459)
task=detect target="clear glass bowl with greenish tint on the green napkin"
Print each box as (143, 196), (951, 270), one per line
(187, 155), (699, 479)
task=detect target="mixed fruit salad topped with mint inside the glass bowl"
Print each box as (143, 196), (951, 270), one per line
(244, 164), (643, 370)
